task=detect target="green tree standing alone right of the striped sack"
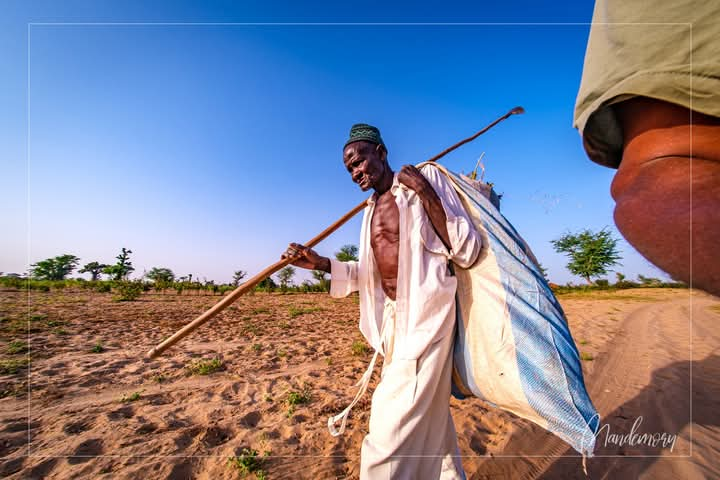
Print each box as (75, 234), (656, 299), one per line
(550, 229), (622, 285)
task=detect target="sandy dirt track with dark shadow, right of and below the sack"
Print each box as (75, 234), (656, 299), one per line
(471, 292), (720, 480)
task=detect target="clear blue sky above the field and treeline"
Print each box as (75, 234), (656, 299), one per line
(0, 1), (672, 283)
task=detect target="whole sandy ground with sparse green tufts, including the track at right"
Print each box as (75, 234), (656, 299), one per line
(0, 289), (720, 480)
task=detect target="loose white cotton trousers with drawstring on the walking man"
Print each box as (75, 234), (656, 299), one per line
(360, 301), (465, 480)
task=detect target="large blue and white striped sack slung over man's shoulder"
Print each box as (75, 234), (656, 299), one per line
(424, 164), (599, 456)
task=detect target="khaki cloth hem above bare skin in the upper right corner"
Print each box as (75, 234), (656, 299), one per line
(574, 0), (720, 168)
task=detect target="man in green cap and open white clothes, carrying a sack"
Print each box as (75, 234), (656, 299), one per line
(283, 124), (481, 480)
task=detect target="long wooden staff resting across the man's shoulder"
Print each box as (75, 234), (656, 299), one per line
(146, 107), (525, 358)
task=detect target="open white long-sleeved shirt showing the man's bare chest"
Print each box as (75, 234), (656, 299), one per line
(330, 164), (481, 359)
